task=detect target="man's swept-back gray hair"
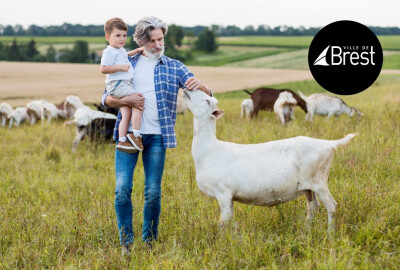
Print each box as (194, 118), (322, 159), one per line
(133, 17), (168, 47)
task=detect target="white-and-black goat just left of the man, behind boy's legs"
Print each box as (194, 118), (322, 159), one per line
(64, 105), (117, 152)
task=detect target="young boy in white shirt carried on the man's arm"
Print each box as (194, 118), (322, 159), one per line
(101, 18), (143, 153)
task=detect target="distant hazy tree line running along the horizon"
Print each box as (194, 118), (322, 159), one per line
(0, 23), (400, 37)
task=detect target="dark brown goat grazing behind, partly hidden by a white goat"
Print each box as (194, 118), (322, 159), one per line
(244, 88), (307, 118)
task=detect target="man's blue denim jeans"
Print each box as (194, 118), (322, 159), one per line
(115, 134), (166, 245)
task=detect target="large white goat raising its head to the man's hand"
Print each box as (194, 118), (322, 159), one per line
(183, 91), (356, 230)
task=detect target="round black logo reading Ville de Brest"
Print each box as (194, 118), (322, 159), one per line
(308, 21), (383, 95)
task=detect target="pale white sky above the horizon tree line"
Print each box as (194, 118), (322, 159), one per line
(0, 0), (400, 29)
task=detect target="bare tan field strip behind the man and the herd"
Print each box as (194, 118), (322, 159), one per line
(0, 62), (400, 106)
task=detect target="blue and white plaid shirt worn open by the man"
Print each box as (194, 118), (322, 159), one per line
(102, 54), (194, 148)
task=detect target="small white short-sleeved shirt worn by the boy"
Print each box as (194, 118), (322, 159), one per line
(100, 45), (133, 83)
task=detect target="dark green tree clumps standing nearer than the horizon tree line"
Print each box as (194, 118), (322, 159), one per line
(0, 25), (218, 63)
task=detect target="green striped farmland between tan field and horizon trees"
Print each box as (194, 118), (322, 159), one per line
(0, 36), (400, 70)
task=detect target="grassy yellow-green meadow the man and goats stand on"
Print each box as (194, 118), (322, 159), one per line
(0, 75), (400, 269)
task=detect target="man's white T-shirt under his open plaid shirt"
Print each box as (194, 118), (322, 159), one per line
(132, 55), (161, 134)
